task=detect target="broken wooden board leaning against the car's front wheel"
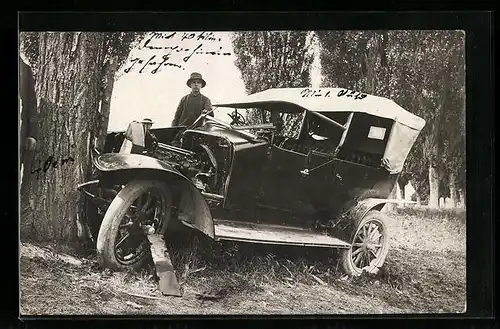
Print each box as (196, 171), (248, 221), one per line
(148, 234), (182, 297)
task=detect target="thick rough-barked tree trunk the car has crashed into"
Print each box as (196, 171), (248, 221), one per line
(21, 32), (108, 241)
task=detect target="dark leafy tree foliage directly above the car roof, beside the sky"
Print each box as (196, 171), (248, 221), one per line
(231, 31), (313, 132)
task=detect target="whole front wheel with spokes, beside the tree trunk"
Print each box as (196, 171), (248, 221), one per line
(97, 180), (172, 270)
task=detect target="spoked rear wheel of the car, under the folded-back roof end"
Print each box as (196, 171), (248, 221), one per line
(341, 210), (389, 276)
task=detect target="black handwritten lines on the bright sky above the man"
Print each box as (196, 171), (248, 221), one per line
(124, 32), (231, 74)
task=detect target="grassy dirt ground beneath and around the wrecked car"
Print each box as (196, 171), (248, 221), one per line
(20, 208), (466, 316)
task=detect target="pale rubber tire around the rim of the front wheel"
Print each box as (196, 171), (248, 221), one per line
(97, 180), (171, 271)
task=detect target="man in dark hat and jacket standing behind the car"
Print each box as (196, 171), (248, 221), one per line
(172, 72), (214, 127)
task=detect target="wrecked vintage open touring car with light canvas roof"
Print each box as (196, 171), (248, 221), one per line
(78, 88), (425, 276)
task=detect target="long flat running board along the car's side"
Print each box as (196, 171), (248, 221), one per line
(214, 219), (350, 248)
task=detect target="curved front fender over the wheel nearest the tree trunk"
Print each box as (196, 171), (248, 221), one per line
(93, 153), (215, 238)
